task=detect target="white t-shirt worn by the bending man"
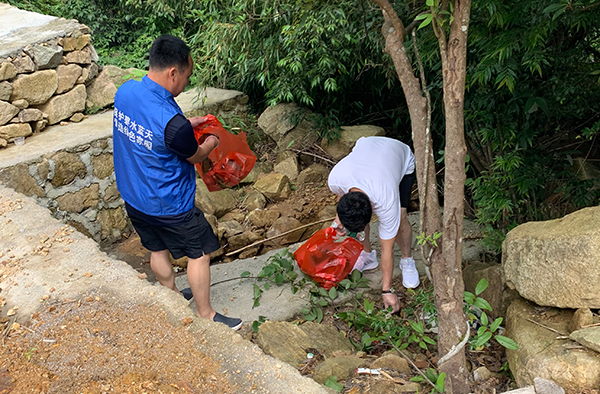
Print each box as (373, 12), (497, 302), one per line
(328, 137), (415, 239)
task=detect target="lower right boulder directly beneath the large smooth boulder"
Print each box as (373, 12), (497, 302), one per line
(504, 299), (600, 391)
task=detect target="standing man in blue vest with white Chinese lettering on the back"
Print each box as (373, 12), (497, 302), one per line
(113, 35), (242, 330)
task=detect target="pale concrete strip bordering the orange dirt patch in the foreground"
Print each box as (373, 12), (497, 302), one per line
(0, 186), (326, 394)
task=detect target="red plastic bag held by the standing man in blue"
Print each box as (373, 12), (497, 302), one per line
(194, 115), (256, 192)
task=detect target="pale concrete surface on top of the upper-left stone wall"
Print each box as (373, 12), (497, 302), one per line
(0, 3), (82, 58)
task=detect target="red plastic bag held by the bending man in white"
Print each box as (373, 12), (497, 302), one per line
(294, 227), (363, 290)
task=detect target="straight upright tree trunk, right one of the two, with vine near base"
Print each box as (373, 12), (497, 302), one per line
(431, 0), (471, 393)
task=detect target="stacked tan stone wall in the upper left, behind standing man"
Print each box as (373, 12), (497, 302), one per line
(0, 24), (116, 148)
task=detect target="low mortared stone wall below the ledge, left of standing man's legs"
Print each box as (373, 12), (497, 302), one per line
(0, 138), (131, 243)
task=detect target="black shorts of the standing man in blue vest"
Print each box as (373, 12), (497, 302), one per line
(130, 208), (221, 259)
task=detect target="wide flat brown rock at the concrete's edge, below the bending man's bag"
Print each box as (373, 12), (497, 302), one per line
(256, 321), (354, 368)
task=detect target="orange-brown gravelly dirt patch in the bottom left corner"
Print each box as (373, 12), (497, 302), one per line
(0, 294), (234, 394)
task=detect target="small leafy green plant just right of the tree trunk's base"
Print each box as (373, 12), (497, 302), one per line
(464, 278), (519, 350)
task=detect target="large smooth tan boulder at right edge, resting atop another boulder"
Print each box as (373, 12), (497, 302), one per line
(502, 207), (600, 309)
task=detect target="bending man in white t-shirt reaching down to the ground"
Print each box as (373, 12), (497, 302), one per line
(329, 137), (420, 312)
